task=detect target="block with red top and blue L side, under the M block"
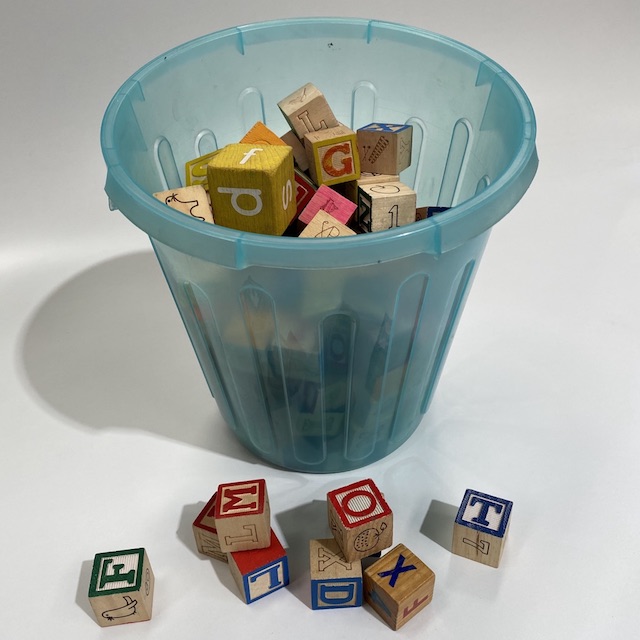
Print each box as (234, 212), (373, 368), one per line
(229, 531), (289, 604)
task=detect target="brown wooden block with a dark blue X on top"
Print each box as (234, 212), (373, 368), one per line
(364, 544), (436, 630)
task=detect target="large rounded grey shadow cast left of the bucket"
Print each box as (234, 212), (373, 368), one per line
(21, 252), (257, 462)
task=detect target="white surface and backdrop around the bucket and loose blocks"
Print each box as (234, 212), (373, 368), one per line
(0, 0), (640, 640)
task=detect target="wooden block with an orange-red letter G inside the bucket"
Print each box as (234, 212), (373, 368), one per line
(304, 124), (360, 186)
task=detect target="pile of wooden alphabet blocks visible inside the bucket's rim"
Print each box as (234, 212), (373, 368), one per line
(154, 83), (446, 238)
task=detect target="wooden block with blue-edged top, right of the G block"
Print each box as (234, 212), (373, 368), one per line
(357, 122), (413, 173)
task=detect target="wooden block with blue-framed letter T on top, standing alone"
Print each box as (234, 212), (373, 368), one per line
(451, 489), (513, 568)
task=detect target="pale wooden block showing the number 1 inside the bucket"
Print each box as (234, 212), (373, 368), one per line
(358, 182), (417, 231)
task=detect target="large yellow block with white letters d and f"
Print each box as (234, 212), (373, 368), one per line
(207, 143), (296, 235)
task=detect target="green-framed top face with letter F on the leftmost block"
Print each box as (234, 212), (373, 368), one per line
(89, 549), (144, 598)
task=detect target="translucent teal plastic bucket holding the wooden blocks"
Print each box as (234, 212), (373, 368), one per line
(102, 18), (538, 472)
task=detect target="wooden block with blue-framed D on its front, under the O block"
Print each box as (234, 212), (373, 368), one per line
(309, 538), (362, 609)
